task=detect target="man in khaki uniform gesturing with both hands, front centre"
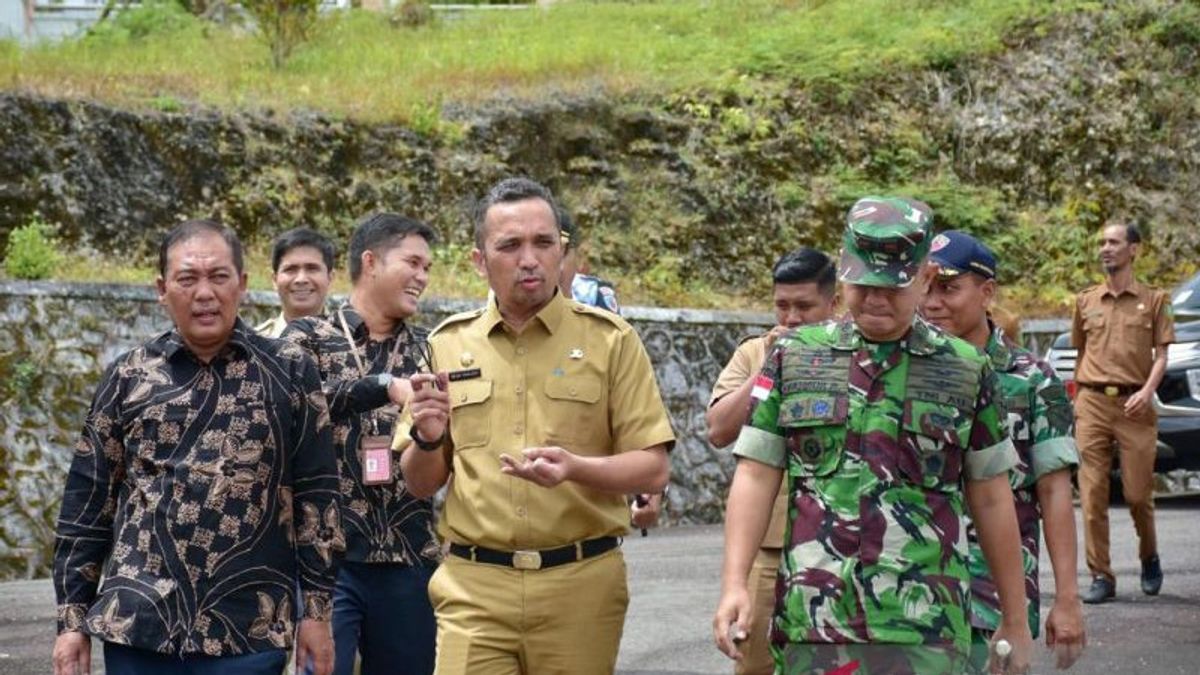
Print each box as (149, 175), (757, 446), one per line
(401, 179), (674, 675)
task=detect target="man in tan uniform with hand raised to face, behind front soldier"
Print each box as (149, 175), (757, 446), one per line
(704, 246), (838, 675)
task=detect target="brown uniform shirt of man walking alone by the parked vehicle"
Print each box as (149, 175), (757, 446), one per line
(1070, 281), (1175, 387)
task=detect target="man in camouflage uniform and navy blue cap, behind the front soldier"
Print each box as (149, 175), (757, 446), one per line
(922, 231), (1084, 670)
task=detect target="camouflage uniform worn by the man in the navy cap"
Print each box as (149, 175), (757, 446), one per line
(967, 325), (1079, 638)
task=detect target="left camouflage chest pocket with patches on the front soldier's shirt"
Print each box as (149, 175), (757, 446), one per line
(778, 394), (850, 478)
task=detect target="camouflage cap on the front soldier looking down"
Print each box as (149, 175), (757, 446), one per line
(838, 197), (934, 288)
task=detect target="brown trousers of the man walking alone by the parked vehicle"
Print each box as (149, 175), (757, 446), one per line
(1075, 387), (1158, 583)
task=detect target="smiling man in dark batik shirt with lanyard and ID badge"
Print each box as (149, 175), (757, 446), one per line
(283, 214), (439, 675)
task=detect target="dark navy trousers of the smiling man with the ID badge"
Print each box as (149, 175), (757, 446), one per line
(334, 561), (437, 675)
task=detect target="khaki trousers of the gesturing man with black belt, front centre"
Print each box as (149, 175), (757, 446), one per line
(430, 548), (629, 675)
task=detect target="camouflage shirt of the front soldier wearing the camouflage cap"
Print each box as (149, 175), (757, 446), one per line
(734, 318), (1015, 673)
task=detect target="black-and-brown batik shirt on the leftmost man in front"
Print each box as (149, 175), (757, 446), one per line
(54, 319), (344, 656)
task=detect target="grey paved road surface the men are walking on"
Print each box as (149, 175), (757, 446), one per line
(0, 496), (1200, 675)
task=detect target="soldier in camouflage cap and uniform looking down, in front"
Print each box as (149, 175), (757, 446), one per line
(713, 197), (1032, 674)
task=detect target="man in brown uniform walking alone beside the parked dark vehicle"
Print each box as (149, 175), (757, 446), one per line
(1070, 219), (1175, 603)
